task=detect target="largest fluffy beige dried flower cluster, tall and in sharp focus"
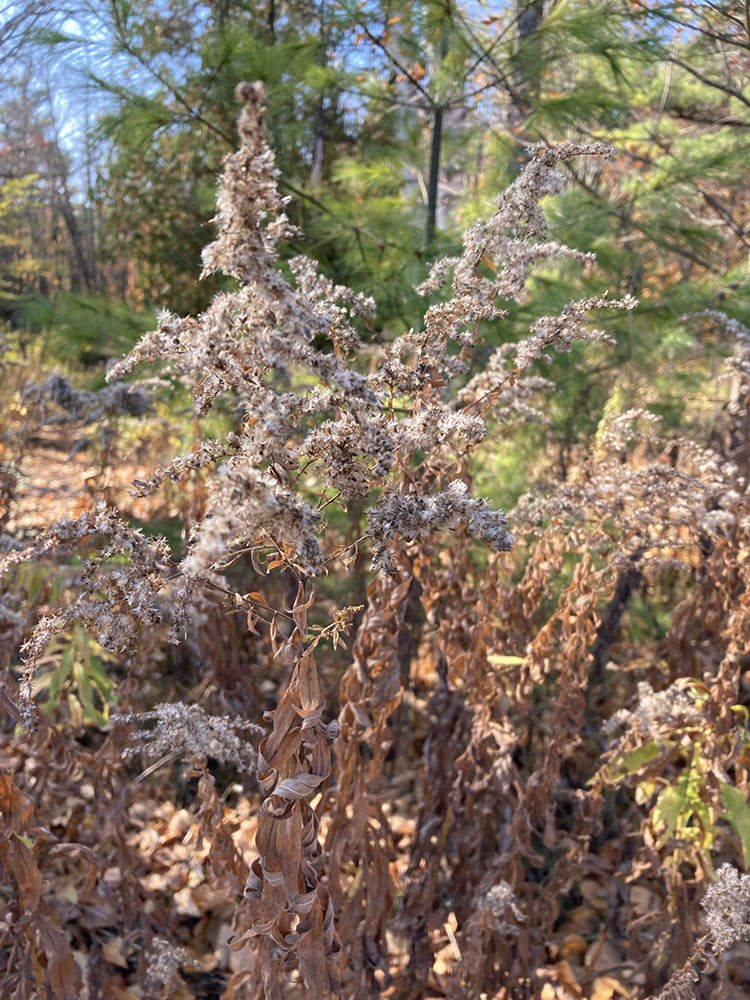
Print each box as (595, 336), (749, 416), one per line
(94, 84), (634, 592)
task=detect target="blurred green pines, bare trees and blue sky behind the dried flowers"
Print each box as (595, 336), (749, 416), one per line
(5, 3), (748, 476)
